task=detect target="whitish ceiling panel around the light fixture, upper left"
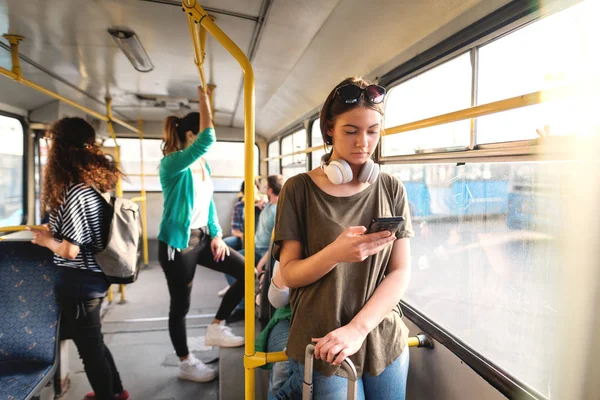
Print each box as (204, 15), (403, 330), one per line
(0, 0), (255, 122)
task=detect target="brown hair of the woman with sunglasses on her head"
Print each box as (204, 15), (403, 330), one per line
(319, 77), (383, 146)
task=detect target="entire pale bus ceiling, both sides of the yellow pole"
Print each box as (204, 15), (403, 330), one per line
(0, 0), (509, 137)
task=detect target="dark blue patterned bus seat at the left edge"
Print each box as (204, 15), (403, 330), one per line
(0, 240), (60, 400)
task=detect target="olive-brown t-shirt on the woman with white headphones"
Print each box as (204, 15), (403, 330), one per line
(274, 173), (413, 376)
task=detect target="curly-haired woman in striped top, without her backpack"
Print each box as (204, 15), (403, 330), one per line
(28, 118), (129, 400)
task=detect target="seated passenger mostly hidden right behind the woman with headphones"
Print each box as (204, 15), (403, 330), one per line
(256, 263), (292, 400)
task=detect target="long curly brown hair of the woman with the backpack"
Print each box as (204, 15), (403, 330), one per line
(41, 117), (122, 213)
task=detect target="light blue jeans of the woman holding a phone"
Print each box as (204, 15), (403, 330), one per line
(275, 346), (410, 400)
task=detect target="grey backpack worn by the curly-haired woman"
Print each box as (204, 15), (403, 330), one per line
(94, 188), (142, 284)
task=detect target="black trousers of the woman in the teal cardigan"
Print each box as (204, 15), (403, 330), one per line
(158, 230), (244, 357)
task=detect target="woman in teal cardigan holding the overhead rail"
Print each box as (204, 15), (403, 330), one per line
(158, 88), (244, 382)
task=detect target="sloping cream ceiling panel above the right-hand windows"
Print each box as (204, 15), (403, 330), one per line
(252, 0), (508, 137)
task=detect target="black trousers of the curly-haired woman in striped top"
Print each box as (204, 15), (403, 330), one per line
(58, 298), (123, 400)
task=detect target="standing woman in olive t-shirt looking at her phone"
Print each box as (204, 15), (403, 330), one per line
(274, 78), (413, 400)
